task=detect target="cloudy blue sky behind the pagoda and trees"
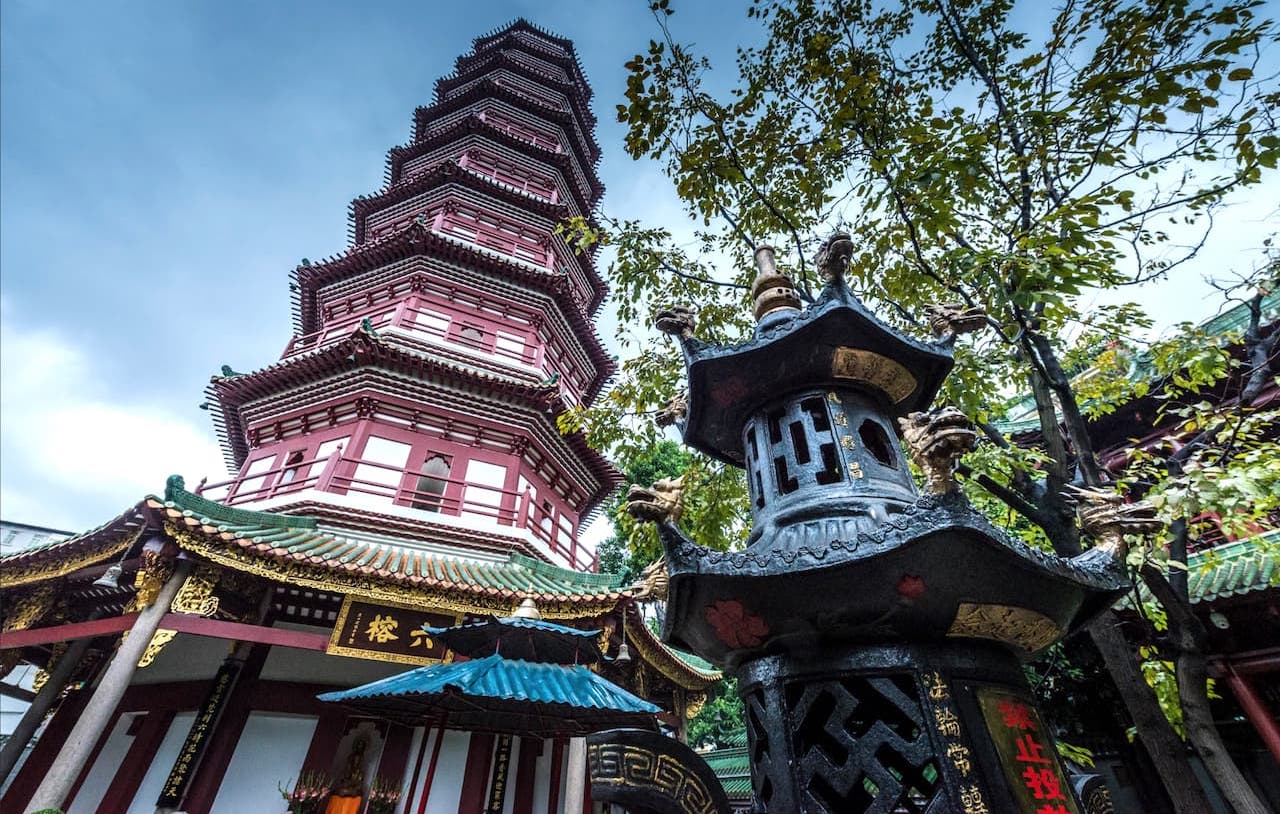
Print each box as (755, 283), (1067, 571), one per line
(0, 0), (1275, 530)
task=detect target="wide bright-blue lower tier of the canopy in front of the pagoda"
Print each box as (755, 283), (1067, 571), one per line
(319, 654), (660, 737)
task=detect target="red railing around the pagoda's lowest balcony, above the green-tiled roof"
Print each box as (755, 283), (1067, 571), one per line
(200, 451), (599, 571)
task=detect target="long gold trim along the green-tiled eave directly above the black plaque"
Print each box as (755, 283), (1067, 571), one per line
(165, 522), (618, 619)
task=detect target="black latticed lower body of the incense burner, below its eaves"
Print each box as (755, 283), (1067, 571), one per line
(737, 641), (1083, 814)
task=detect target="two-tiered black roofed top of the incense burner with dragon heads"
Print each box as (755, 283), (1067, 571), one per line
(627, 234), (1126, 667)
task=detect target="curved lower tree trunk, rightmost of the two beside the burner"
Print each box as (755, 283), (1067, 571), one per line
(1142, 564), (1267, 814)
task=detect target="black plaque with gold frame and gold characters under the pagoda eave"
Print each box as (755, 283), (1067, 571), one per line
(325, 594), (462, 666)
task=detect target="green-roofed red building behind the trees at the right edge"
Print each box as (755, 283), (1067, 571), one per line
(997, 291), (1280, 814)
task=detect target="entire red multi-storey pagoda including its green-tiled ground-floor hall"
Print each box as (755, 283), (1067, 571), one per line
(0, 20), (719, 814)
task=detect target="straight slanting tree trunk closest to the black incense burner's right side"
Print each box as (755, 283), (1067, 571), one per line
(1088, 611), (1218, 814)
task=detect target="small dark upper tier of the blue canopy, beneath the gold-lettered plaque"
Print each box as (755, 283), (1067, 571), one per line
(422, 616), (600, 664)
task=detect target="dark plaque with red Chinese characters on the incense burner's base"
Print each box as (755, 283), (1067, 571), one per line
(978, 689), (1080, 814)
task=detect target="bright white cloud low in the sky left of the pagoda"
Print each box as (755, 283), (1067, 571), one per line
(0, 307), (224, 531)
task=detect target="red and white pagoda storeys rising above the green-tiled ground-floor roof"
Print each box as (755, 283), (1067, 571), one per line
(205, 12), (617, 570)
